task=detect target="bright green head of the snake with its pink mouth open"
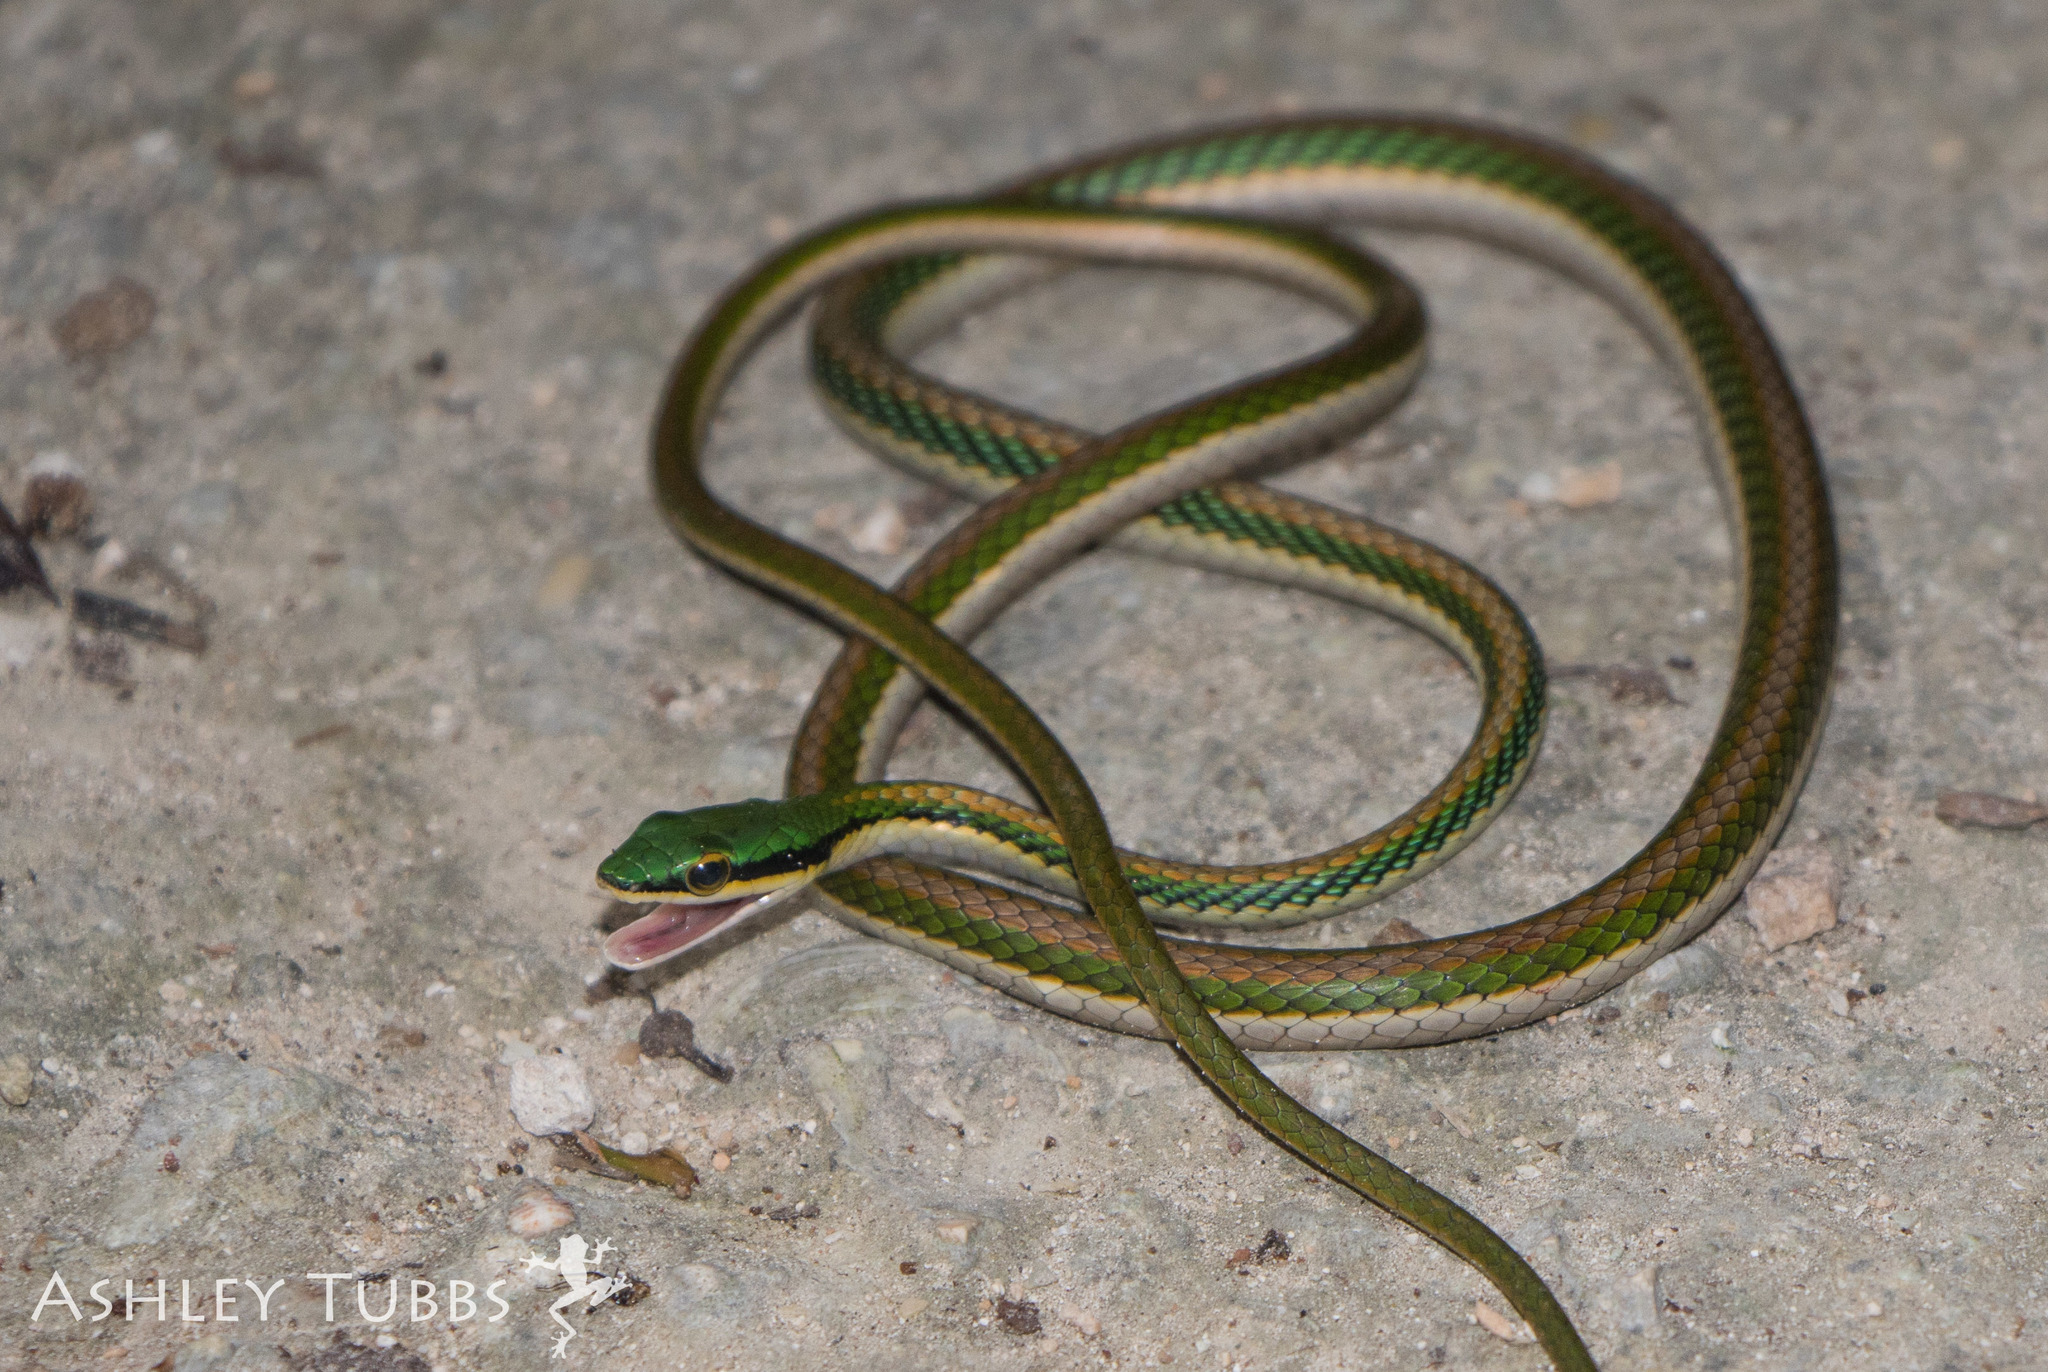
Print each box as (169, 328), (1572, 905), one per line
(598, 801), (834, 971)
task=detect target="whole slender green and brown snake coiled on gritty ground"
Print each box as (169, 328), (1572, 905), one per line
(598, 115), (1837, 1368)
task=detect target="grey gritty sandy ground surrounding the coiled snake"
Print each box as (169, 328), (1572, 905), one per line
(0, 0), (2048, 1372)
